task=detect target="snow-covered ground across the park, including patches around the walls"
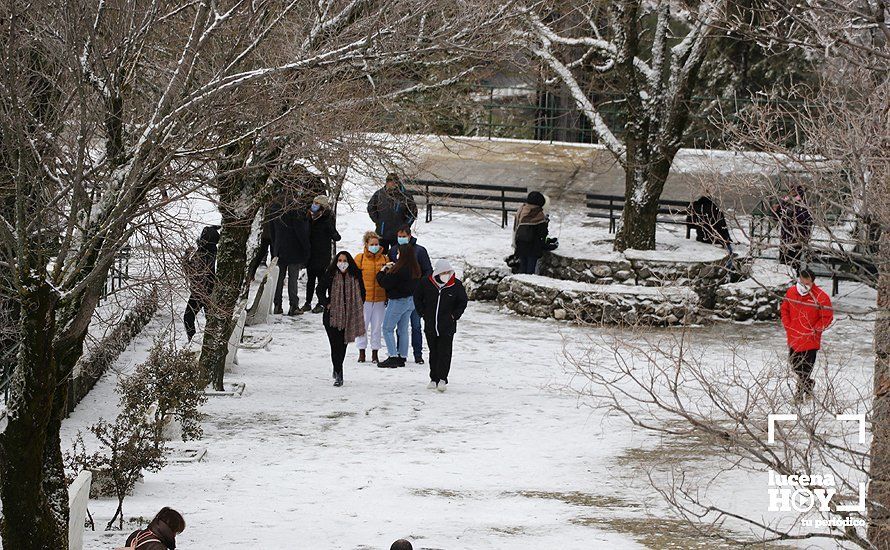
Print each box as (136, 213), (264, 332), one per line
(63, 174), (873, 550)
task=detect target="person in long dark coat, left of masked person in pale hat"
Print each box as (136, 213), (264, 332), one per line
(270, 194), (309, 315)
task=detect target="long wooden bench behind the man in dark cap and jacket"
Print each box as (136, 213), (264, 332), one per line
(406, 180), (528, 227)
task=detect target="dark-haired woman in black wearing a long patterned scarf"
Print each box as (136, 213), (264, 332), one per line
(316, 250), (365, 387)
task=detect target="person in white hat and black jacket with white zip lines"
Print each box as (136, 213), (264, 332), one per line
(414, 260), (467, 392)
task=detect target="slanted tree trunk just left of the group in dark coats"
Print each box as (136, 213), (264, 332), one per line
(200, 210), (255, 391)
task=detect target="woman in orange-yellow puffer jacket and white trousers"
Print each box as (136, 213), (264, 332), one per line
(355, 231), (389, 363)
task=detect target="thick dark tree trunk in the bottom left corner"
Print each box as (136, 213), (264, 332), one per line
(0, 277), (68, 550)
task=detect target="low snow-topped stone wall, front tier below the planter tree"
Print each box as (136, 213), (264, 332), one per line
(498, 275), (699, 326)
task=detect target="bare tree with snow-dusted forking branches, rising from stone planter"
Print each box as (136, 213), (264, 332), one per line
(516, 0), (728, 250)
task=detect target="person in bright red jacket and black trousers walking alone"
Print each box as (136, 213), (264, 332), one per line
(781, 269), (834, 399)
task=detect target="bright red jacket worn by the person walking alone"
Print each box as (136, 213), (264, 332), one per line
(781, 284), (834, 351)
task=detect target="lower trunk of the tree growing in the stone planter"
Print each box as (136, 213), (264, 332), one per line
(614, 146), (672, 252)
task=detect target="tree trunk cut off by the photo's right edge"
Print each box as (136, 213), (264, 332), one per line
(867, 233), (890, 548)
